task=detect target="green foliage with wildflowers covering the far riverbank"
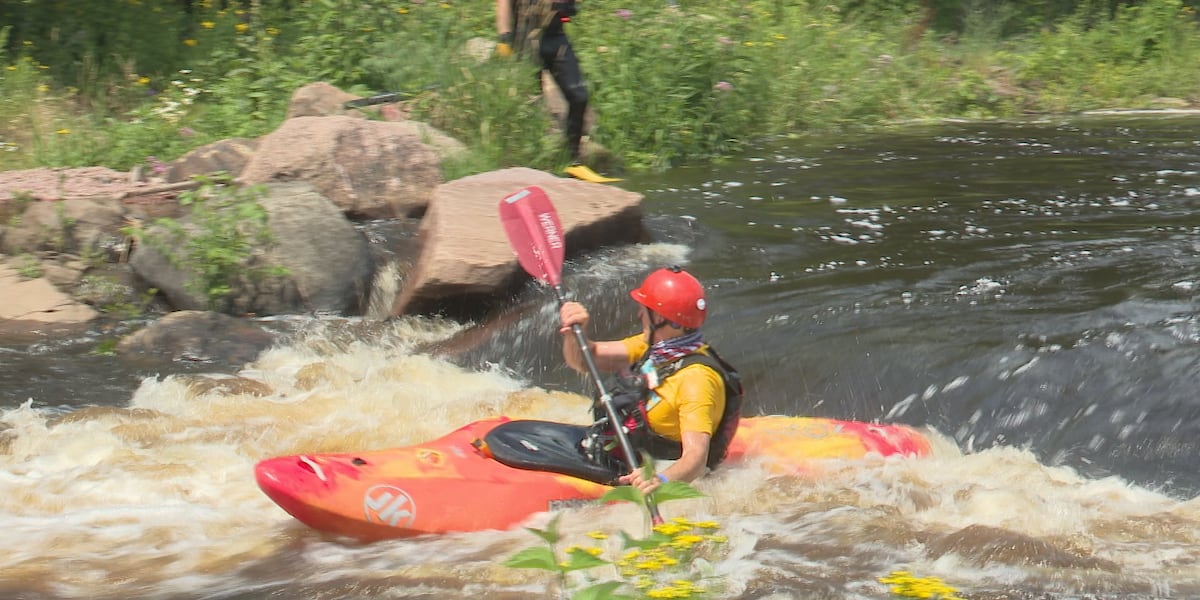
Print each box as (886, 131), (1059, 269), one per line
(0, 0), (1200, 176)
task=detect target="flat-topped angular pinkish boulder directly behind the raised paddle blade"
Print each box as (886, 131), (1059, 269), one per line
(391, 168), (644, 317)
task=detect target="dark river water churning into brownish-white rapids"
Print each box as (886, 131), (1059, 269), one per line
(0, 113), (1200, 600)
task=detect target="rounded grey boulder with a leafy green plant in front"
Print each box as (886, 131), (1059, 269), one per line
(130, 182), (373, 314)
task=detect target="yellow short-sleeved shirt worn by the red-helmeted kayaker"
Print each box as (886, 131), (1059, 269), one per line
(622, 334), (725, 442)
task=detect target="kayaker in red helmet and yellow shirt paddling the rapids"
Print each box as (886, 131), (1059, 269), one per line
(559, 266), (742, 493)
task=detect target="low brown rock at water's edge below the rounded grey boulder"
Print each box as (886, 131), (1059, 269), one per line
(116, 311), (275, 366)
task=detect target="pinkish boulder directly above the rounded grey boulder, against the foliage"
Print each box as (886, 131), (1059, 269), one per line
(239, 116), (462, 218)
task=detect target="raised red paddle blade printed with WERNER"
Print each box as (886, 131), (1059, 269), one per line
(500, 186), (566, 286)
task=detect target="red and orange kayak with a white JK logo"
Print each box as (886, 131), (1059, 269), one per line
(254, 416), (930, 541)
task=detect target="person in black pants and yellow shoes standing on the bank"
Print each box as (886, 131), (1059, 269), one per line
(496, 0), (611, 182)
